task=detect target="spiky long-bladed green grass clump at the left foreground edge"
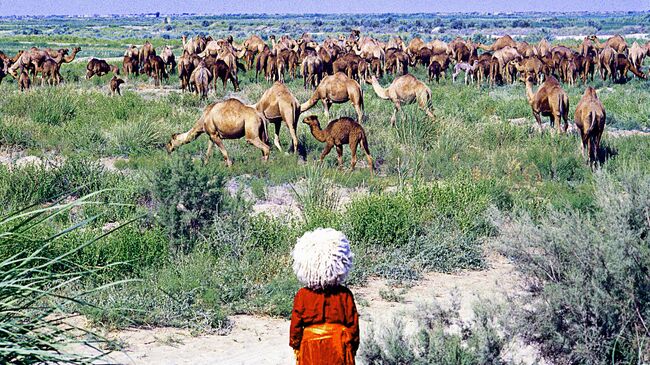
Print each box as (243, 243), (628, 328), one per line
(0, 197), (126, 365)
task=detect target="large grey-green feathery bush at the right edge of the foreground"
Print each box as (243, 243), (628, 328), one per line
(493, 170), (650, 364)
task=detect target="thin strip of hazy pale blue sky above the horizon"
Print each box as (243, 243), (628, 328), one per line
(0, 0), (650, 16)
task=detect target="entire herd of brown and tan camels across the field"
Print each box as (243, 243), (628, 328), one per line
(0, 30), (650, 166)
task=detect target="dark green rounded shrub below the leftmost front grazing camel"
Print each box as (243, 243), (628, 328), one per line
(152, 154), (224, 252)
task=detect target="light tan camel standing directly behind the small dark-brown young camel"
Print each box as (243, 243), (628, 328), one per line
(300, 72), (363, 121)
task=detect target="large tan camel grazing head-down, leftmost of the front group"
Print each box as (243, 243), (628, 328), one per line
(165, 99), (270, 167)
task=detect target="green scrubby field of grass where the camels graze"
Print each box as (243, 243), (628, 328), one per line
(0, 13), (650, 363)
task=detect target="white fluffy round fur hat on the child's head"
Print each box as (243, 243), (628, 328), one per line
(292, 228), (354, 289)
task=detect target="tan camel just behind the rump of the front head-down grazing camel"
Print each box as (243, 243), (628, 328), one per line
(253, 82), (300, 154)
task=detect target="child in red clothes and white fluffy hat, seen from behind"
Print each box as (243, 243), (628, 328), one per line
(289, 228), (359, 365)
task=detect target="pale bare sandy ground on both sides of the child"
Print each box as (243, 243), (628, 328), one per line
(69, 256), (535, 365)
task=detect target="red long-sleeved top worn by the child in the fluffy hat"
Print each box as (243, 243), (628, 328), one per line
(289, 286), (359, 364)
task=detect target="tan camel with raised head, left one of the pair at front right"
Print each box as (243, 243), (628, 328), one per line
(526, 76), (569, 132)
